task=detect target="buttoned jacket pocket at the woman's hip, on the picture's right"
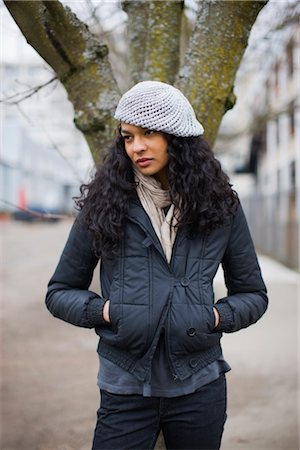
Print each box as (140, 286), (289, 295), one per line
(168, 304), (222, 355)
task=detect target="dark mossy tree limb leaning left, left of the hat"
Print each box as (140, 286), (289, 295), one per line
(5, 0), (120, 161)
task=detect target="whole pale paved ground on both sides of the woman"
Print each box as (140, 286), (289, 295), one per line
(0, 221), (299, 450)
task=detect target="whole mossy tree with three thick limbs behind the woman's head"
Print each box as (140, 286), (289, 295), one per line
(5, 0), (267, 156)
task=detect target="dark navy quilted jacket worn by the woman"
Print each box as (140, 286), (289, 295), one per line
(46, 199), (268, 382)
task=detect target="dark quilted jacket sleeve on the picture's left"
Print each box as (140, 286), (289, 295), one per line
(46, 216), (105, 328)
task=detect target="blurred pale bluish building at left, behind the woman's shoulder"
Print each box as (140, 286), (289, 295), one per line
(0, 117), (78, 213)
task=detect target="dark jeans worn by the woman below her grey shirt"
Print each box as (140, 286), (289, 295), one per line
(93, 375), (226, 450)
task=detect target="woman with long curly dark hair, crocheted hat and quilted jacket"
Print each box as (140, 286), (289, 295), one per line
(46, 81), (267, 450)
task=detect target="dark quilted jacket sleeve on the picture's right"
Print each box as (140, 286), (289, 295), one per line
(215, 206), (268, 333)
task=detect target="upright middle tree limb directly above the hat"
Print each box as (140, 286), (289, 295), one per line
(122, 0), (183, 85)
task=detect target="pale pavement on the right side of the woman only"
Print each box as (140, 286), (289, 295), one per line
(216, 255), (300, 450)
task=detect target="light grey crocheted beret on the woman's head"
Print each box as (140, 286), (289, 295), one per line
(115, 81), (204, 137)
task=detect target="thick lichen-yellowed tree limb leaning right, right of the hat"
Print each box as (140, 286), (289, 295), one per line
(176, 0), (267, 145)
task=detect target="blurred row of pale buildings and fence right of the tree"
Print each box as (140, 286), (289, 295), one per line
(218, 23), (300, 269)
